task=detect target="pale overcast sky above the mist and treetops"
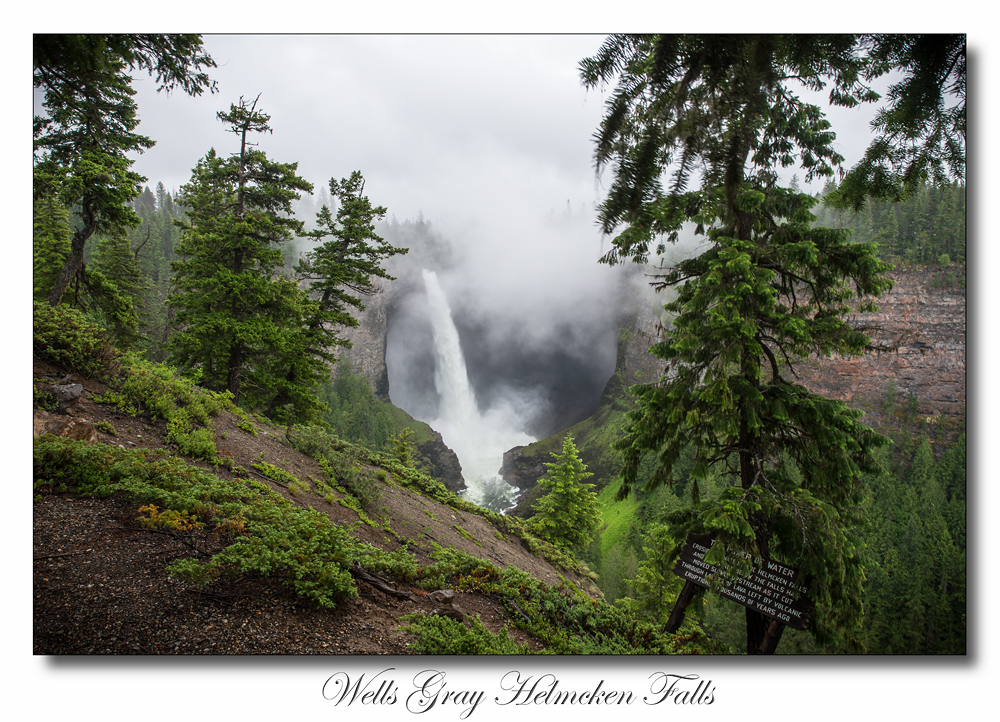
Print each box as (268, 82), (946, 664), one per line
(123, 35), (892, 229)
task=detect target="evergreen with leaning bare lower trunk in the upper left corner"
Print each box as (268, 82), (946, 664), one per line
(33, 35), (215, 305)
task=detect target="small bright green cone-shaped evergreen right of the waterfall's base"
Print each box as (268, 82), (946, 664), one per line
(531, 435), (601, 550)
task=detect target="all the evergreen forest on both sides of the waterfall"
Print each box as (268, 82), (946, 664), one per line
(33, 36), (966, 654)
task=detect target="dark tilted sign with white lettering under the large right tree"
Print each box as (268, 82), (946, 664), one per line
(674, 536), (813, 629)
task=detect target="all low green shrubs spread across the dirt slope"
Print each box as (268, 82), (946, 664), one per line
(34, 306), (721, 654)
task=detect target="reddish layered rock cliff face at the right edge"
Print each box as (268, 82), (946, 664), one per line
(799, 267), (966, 425)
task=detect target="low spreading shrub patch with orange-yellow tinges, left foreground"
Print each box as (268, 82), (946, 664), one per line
(34, 438), (372, 607)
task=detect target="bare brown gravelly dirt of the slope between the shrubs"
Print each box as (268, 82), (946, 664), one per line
(33, 361), (589, 654)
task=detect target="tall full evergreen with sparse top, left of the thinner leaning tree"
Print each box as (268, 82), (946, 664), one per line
(169, 98), (312, 406)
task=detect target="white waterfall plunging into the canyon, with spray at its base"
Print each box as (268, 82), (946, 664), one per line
(423, 270), (535, 511)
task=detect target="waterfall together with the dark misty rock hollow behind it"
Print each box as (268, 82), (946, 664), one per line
(385, 270), (615, 511)
